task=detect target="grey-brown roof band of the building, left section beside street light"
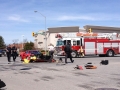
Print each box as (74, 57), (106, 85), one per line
(48, 26), (79, 33)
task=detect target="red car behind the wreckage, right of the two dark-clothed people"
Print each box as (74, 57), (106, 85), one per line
(20, 50), (41, 61)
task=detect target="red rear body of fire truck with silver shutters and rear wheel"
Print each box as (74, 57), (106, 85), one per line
(84, 42), (120, 57)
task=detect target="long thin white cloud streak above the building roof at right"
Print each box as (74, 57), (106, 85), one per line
(56, 13), (120, 21)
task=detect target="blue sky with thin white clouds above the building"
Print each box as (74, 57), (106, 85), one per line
(0, 0), (120, 44)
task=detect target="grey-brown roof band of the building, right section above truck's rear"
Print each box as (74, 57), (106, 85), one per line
(84, 25), (120, 33)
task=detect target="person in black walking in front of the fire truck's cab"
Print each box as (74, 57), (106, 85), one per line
(64, 42), (74, 64)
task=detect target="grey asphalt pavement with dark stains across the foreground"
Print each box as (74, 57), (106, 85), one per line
(0, 55), (120, 90)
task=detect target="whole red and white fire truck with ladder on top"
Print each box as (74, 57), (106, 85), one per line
(55, 32), (120, 57)
